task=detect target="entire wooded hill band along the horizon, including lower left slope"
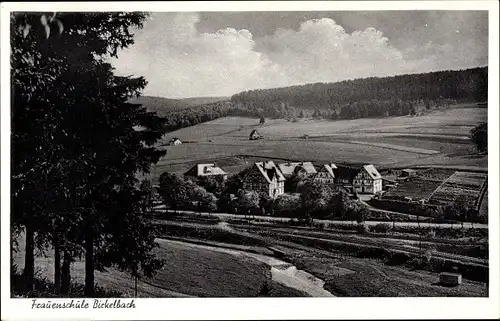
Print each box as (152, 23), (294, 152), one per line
(142, 67), (488, 131)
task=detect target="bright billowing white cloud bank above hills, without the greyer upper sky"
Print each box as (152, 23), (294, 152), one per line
(113, 13), (481, 97)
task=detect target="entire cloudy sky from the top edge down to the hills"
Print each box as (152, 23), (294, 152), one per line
(112, 11), (488, 98)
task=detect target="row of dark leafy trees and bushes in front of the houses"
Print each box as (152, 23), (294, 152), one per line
(157, 172), (369, 222)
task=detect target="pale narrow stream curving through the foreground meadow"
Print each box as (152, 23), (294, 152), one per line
(157, 239), (334, 297)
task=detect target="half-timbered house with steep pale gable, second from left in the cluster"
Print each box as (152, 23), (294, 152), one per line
(242, 161), (285, 198)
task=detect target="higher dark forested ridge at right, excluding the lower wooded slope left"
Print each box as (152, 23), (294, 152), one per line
(230, 67), (488, 119)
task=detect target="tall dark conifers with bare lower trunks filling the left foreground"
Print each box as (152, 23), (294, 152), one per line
(10, 12), (165, 297)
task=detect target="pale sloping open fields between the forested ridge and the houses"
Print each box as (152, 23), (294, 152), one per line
(152, 106), (487, 177)
